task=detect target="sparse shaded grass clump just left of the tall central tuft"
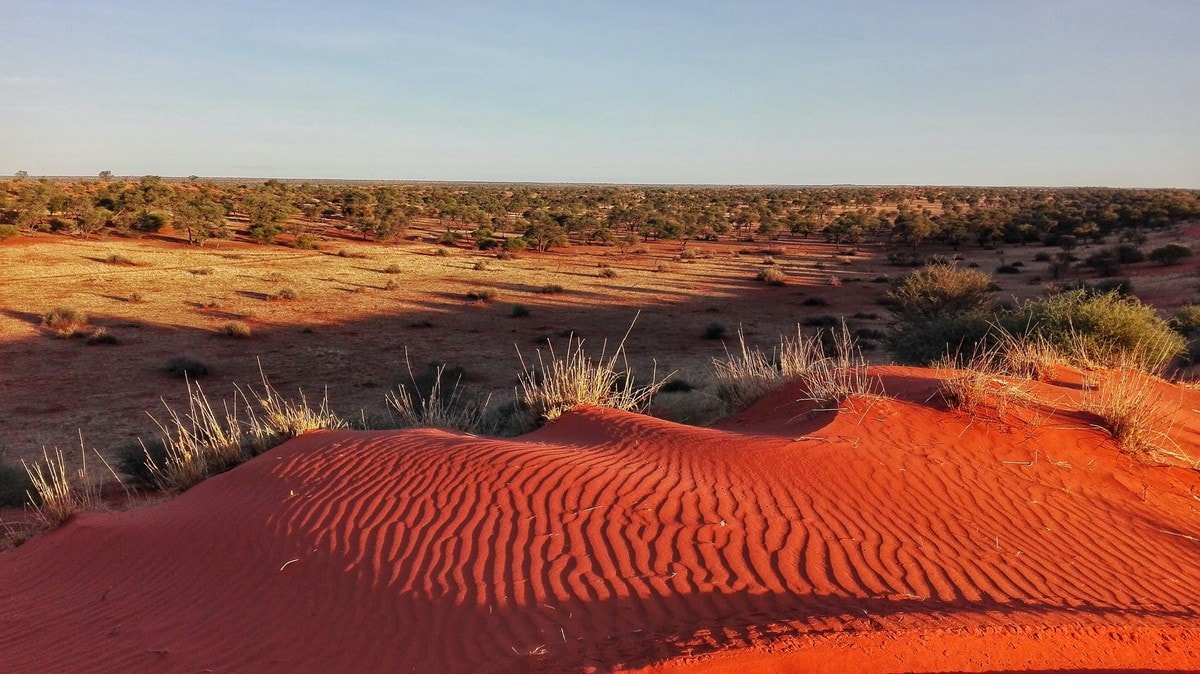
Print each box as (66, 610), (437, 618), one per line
(386, 354), (488, 433)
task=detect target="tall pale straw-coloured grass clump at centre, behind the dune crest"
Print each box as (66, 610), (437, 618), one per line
(517, 319), (670, 428)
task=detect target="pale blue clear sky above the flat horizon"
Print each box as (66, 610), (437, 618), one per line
(0, 0), (1200, 183)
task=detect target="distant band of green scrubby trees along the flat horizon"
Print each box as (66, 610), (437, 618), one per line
(0, 171), (1200, 253)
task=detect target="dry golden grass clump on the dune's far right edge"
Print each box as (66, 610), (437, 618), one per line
(1081, 367), (1196, 467)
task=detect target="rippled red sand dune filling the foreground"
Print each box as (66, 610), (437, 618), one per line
(0, 368), (1200, 672)
